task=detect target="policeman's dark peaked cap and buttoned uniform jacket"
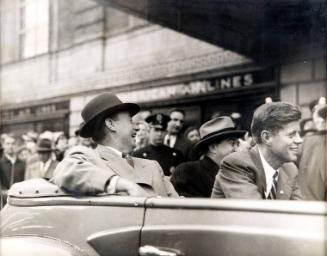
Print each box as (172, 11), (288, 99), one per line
(132, 114), (184, 176)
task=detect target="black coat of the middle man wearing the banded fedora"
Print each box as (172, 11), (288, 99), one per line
(170, 157), (219, 197)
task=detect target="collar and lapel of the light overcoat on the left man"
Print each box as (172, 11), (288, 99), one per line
(96, 145), (152, 186)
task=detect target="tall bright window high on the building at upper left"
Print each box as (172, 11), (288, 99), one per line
(18, 0), (49, 58)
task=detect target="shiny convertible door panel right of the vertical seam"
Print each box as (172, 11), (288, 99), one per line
(140, 199), (327, 256)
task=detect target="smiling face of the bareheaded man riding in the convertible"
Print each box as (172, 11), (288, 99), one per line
(269, 121), (303, 165)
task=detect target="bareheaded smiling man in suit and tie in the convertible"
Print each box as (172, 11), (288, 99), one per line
(212, 102), (302, 200)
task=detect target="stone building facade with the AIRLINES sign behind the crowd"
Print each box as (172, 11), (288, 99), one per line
(0, 0), (327, 135)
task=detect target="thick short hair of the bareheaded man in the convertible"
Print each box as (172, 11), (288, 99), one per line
(251, 102), (301, 144)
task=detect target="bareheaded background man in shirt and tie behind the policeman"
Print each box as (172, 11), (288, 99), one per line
(164, 108), (192, 159)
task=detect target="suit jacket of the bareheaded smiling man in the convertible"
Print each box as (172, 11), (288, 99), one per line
(211, 147), (303, 200)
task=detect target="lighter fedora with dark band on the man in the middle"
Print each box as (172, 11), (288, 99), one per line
(194, 116), (246, 151)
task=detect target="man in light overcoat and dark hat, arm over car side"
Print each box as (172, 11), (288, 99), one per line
(52, 93), (177, 196)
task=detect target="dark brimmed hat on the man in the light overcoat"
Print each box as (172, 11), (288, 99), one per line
(79, 92), (140, 138)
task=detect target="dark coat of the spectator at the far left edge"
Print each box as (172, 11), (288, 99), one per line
(0, 155), (25, 190)
